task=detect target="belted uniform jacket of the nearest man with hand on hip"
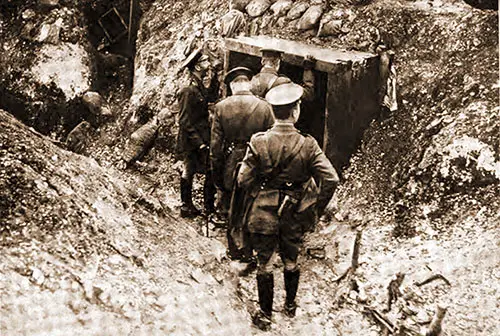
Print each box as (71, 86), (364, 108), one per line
(238, 122), (339, 234)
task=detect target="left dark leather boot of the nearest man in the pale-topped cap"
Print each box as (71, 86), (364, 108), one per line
(252, 273), (274, 331)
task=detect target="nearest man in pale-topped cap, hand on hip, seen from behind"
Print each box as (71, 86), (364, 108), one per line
(237, 83), (339, 330)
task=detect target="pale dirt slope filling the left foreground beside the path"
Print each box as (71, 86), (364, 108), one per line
(0, 111), (249, 335)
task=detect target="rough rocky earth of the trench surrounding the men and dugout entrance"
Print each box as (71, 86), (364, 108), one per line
(0, 0), (500, 335)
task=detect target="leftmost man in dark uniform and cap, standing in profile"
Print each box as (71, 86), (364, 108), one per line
(177, 48), (219, 218)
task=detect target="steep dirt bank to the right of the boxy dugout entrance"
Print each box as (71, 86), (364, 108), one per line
(338, 0), (499, 234)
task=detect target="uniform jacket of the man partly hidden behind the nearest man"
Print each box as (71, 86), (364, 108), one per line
(210, 91), (274, 191)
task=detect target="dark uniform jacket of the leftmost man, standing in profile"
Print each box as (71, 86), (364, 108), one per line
(177, 76), (219, 154)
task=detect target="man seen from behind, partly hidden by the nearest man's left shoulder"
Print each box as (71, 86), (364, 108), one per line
(210, 67), (274, 261)
